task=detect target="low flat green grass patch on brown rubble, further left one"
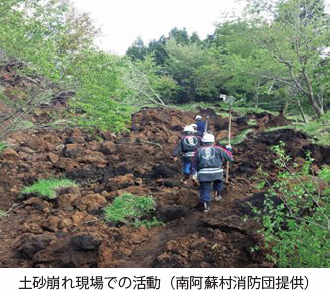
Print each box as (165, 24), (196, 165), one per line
(22, 178), (77, 199)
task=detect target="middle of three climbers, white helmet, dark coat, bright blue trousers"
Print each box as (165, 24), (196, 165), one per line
(174, 126), (201, 184)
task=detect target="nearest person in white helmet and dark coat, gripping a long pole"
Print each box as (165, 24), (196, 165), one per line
(192, 133), (233, 212)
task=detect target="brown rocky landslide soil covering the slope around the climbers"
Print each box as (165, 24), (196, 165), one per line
(0, 103), (330, 267)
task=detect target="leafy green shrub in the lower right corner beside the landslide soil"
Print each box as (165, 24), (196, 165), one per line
(254, 142), (329, 268)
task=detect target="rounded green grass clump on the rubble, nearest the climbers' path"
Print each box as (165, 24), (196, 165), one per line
(104, 193), (158, 226)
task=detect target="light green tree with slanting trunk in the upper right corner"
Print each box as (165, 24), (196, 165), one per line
(247, 0), (328, 117)
